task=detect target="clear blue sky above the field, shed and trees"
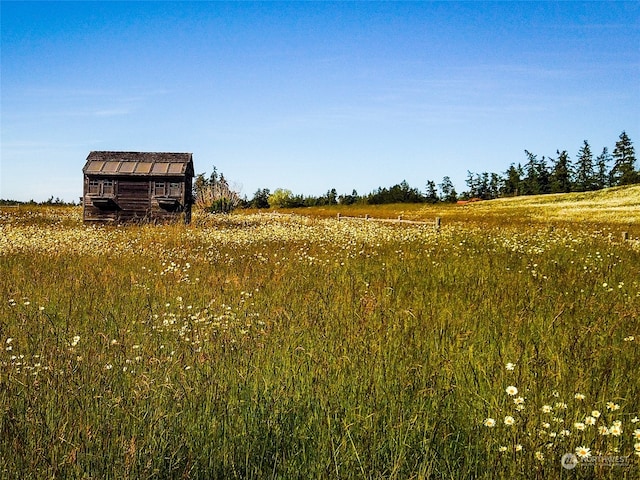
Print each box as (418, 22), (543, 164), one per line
(0, 1), (640, 201)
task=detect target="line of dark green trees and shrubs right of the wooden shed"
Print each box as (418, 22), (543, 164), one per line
(194, 131), (640, 212)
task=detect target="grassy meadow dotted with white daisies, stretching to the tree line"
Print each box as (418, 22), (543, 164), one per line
(0, 187), (640, 479)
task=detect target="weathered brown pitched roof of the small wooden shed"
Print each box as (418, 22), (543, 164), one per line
(82, 152), (193, 177)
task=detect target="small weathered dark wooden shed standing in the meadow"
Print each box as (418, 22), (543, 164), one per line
(82, 152), (194, 223)
